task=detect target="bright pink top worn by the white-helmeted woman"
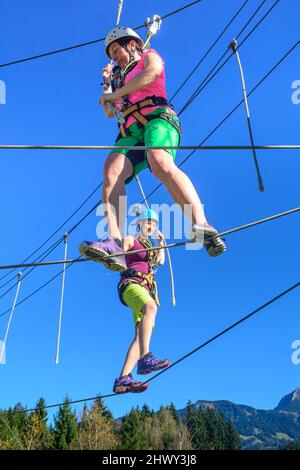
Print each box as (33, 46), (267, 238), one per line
(125, 49), (167, 128)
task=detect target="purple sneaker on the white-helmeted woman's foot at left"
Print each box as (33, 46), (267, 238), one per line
(79, 237), (126, 272)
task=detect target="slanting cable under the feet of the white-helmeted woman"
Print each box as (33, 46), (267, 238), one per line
(0, 207), (300, 272)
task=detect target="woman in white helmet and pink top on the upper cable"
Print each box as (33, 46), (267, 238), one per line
(80, 26), (226, 271)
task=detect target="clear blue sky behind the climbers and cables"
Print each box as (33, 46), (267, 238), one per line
(0, 0), (300, 416)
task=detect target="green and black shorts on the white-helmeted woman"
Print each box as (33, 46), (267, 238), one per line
(115, 108), (180, 184)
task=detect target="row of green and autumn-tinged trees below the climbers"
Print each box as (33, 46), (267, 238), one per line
(0, 397), (241, 450)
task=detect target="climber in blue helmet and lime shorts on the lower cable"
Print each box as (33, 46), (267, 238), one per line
(113, 209), (170, 393)
